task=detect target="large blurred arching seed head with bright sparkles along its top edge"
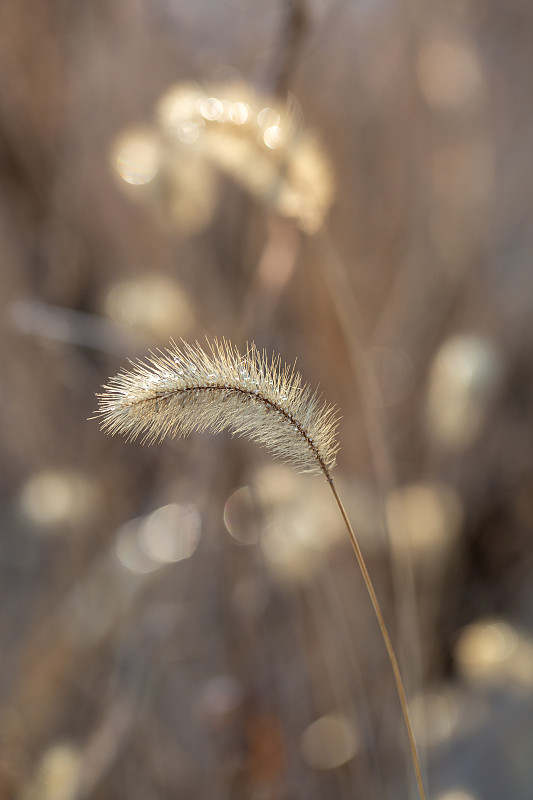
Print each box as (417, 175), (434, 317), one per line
(156, 82), (334, 233)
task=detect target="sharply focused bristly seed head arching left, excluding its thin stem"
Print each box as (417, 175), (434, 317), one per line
(96, 339), (339, 480)
